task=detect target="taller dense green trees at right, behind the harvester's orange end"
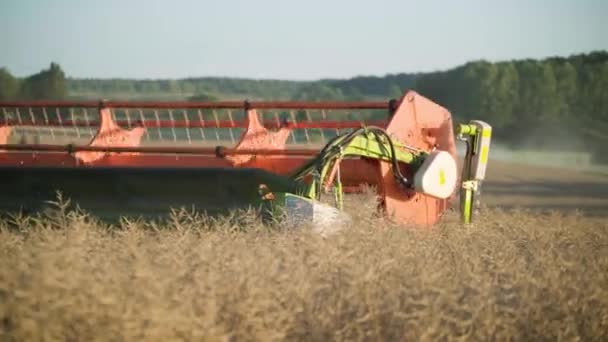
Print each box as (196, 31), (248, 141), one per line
(416, 52), (608, 151)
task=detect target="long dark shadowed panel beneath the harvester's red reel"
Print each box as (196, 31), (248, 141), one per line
(0, 167), (299, 220)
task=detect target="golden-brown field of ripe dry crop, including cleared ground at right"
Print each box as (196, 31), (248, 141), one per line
(0, 163), (608, 341)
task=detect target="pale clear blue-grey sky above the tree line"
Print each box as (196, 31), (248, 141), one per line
(0, 0), (608, 80)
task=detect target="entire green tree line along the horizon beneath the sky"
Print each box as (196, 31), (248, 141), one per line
(0, 51), (608, 159)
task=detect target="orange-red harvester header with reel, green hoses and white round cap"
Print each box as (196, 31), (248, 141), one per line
(0, 91), (491, 227)
